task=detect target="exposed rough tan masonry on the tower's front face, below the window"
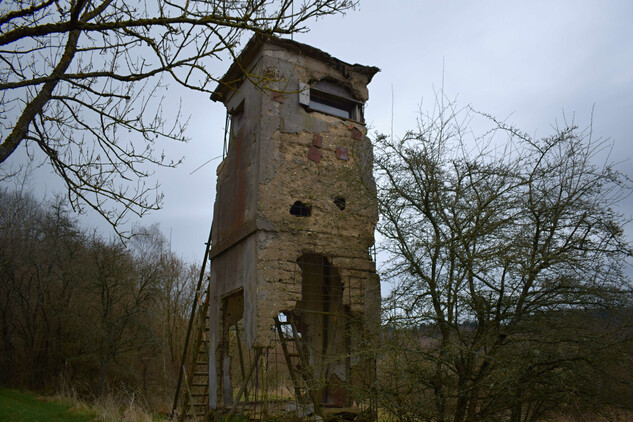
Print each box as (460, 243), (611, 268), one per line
(257, 122), (379, 346)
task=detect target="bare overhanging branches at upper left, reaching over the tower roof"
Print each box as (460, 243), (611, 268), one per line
(0, 0), (356, 234)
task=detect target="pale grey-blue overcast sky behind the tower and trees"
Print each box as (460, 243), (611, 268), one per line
(4, 0), (633, 274)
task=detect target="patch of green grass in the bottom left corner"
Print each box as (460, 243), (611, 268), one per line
(0, 389), (95, 422)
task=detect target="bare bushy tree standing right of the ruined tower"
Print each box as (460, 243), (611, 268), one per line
(376, 95), (631, 422)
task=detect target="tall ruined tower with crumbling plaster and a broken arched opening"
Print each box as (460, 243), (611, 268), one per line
(209, 36), (380, 419)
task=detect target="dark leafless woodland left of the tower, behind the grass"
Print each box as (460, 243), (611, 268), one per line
(0, 190), (198, 405)
